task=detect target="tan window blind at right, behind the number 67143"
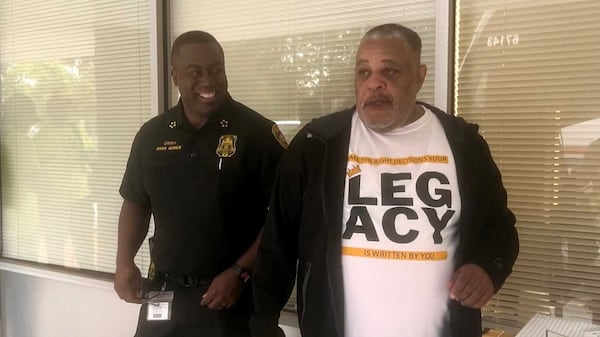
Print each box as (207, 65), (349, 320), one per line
(455, 0), (600, 330)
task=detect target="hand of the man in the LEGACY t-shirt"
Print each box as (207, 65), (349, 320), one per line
(448, 264), (494, 309)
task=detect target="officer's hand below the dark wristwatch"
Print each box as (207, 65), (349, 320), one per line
(200, 268), (243, 310)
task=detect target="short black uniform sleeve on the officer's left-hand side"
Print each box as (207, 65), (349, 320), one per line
(119, 130), (150, 208)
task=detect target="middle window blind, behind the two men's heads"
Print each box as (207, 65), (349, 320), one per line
(171, 0), (436, 141)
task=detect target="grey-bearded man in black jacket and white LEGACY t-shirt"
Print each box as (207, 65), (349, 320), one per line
(253, 24), (518, 337)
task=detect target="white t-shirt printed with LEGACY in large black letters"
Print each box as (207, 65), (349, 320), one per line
(341, 108), (460, 337)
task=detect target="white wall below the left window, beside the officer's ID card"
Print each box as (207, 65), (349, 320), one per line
(0, 262), (300, 337)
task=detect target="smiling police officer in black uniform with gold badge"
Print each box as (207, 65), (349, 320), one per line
(114, 31), (287, 337)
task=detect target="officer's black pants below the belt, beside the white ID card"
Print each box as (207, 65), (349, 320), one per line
(135, 278), (251, 337)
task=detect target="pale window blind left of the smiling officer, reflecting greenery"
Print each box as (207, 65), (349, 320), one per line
(0, 0), (151, 272)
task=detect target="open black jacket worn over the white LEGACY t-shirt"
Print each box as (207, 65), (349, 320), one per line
(253, 103), (519, 337)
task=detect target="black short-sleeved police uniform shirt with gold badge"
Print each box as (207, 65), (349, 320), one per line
(120, 97), (287, 278)
